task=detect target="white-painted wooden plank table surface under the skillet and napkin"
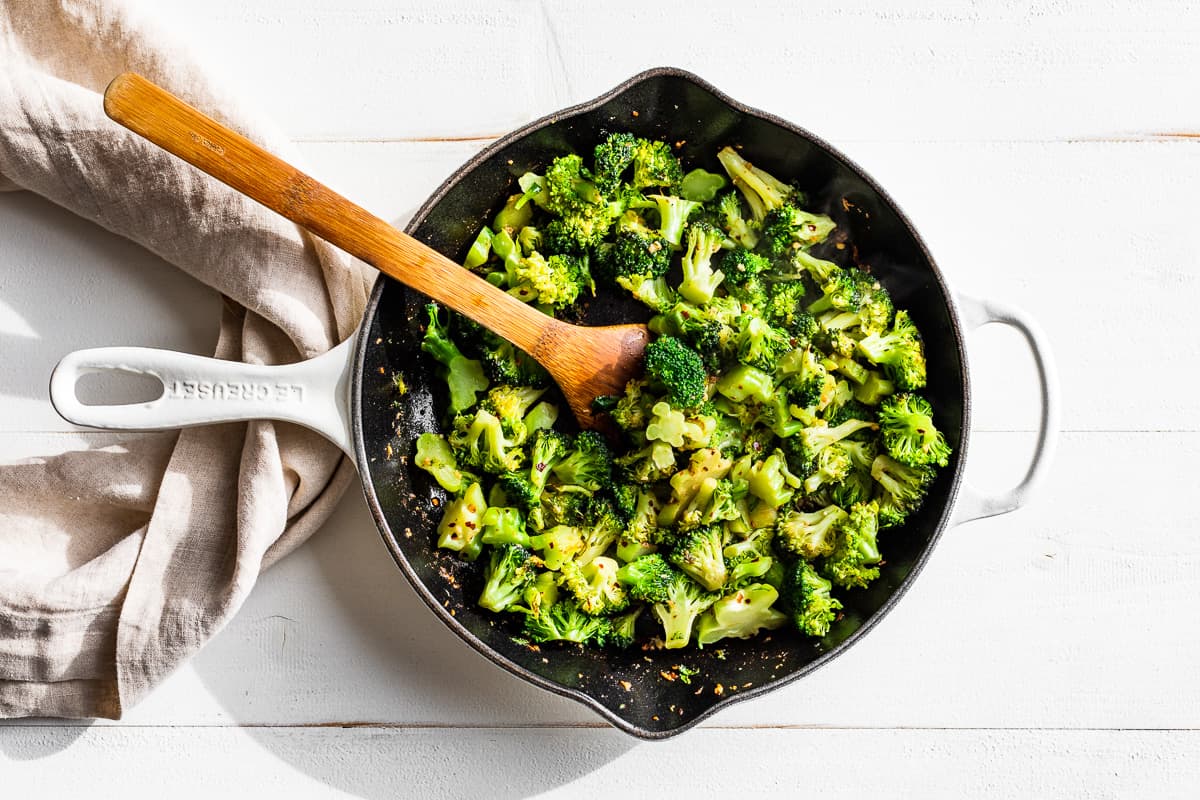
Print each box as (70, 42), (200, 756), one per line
(0, 0), (1200, 798)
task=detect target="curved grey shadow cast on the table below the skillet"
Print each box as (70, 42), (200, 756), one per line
(192, 486), (638, 800)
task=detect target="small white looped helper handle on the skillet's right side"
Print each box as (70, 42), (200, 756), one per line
(950, 294), (1061, 527)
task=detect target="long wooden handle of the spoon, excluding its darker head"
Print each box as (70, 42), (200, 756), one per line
(104, 72), (552, 353)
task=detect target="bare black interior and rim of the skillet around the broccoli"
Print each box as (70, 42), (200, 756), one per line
(354, 70), (968, 739)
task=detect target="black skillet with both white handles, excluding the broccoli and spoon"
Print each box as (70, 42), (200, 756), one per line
(52, 68), (1057, 739)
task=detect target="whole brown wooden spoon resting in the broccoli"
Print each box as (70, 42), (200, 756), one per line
(104, 72), (649, 428)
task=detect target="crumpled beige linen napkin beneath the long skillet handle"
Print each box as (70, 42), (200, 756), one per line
(0, 0), (371, 717)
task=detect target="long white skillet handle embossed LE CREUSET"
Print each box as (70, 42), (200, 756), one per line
(50, 336), (356, 456)
